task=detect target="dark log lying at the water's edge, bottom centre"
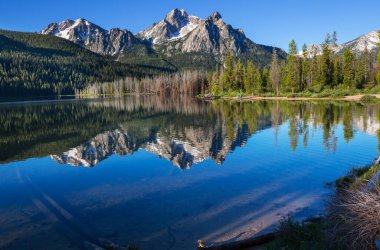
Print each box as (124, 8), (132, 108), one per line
(198, 233), (276, 250)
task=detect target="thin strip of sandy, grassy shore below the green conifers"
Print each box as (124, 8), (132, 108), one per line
(208, 94), (380, 101)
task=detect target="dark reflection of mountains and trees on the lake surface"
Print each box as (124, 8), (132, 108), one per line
(0, 96), (379, 169)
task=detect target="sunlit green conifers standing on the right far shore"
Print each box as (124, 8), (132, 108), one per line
(207, 33), (380, 95)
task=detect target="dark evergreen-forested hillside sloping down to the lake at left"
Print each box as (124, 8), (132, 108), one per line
(0, 30), (166, 97)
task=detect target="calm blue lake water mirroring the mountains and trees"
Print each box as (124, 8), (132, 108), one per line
(0, 97), (380, 249)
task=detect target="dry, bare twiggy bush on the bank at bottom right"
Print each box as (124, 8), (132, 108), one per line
(326, 182), (380, 249)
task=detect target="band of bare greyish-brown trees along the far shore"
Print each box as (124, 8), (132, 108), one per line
(76, 71), (207, 97)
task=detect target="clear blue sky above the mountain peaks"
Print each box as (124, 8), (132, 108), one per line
(0, 0), (380, 49)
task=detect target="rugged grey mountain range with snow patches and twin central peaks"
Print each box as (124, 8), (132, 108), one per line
(40, 9), (286, 68)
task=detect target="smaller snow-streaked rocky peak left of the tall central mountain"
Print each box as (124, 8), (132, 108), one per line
(41, 18), (143, 55)
